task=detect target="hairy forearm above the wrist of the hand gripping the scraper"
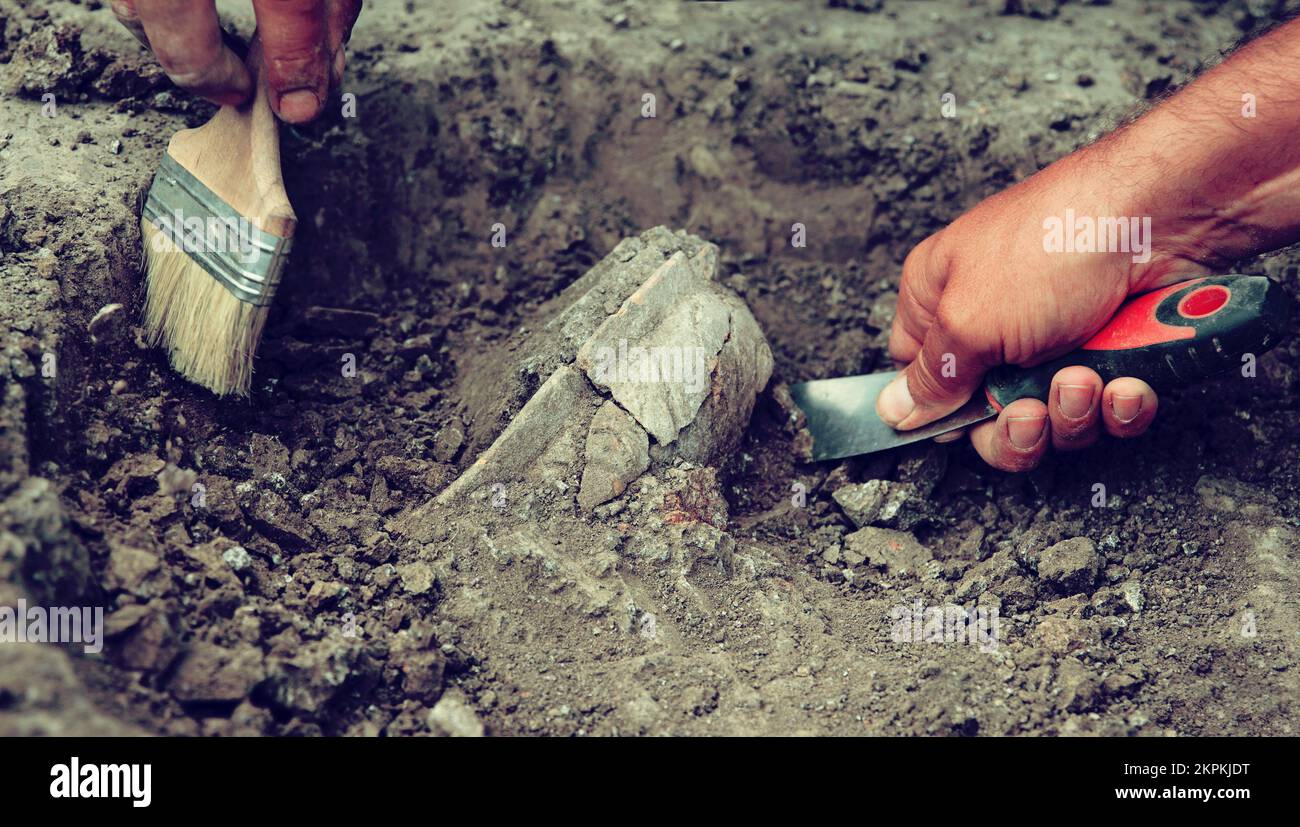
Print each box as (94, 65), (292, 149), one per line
(1096, 21), (1300, 280)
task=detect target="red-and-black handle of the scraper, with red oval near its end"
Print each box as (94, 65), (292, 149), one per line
(984, 276), (1291, 411)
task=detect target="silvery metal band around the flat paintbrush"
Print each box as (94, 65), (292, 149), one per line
(144, 153), (293, 307)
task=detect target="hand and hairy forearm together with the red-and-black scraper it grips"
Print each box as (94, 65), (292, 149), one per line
(792, 21), (1300, 471)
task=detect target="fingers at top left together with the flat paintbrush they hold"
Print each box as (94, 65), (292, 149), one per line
(125, 0), (361, 395)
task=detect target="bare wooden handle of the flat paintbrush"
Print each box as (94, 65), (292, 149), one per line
(168, 35), (298, 238)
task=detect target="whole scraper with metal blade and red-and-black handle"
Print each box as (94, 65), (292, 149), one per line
(790, 274), (1291, 460)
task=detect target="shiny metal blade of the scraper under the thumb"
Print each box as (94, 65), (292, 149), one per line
(790, 371), (997, 460)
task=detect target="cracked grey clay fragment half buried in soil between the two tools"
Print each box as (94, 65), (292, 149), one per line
(423, 228), (772, 516)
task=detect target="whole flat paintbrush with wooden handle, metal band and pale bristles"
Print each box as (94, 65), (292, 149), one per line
(140, 36), (298, 397)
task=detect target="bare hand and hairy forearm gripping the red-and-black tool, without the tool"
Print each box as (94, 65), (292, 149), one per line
(876, 16), (1300, 471)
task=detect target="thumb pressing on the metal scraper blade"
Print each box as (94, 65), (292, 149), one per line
(876, 312), (995, 430)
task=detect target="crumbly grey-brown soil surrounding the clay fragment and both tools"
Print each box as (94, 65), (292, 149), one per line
(0, 0), (1300, 736)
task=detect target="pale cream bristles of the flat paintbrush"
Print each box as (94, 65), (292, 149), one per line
(140, 221), (268, 397)
